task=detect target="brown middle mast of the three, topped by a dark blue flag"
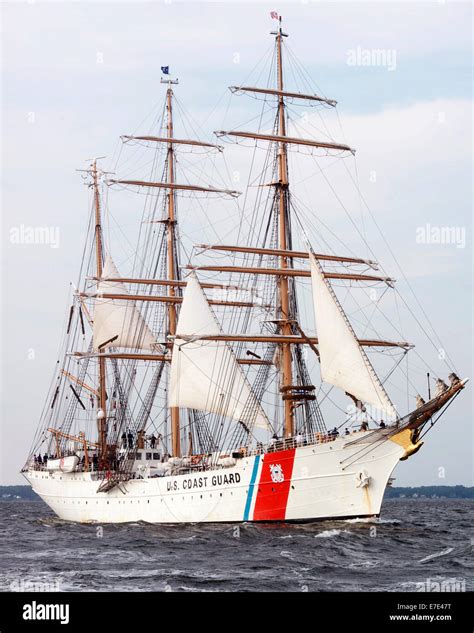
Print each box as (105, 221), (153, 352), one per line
(162, 79), (181, 457)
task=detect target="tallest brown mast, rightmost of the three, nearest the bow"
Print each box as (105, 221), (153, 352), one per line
(272, 17), (294, 437)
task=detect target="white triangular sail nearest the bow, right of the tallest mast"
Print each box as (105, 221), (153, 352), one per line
(309, 253), (396, 417)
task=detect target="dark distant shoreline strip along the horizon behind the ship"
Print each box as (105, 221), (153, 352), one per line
(0, 486), (474, 501)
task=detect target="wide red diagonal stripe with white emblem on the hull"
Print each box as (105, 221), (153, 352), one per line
(253, 448), (296, 521)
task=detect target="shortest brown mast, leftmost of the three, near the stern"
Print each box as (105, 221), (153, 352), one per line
(92, 159), (107, 462)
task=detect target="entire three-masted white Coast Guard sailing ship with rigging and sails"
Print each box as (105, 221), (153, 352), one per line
(22, 14), (466, 523)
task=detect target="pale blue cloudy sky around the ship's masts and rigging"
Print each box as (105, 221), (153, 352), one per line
(0, 0), (473, 485)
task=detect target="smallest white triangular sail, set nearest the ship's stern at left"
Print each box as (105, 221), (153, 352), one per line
(93, 255), (156, 351)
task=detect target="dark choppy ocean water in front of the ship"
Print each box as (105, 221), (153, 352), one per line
(0, 499), (474, 591)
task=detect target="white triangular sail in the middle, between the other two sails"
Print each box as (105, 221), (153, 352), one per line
(169, 275), (269, 429)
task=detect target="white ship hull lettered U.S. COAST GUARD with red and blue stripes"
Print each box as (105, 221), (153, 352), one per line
(25, 432), (410, 523)
